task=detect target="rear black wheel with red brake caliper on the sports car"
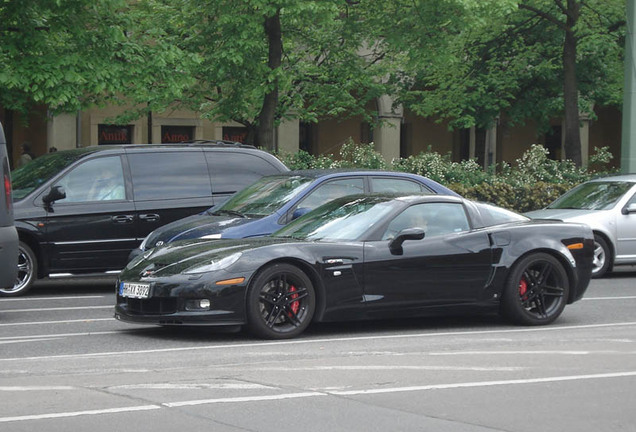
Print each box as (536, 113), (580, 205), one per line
(501, 253), (569, 325)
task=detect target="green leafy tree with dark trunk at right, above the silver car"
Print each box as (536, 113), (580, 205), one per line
(395, 0), (624, 165)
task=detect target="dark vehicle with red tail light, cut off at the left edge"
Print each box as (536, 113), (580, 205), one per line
(0, 123), (18, 289)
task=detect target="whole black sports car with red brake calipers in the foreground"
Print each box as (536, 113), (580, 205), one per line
(115, 195), (594, 338)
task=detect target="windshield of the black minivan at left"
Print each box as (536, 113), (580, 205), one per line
(11, 149), (96, 201)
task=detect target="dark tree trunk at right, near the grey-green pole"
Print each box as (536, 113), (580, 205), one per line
(563, 0), (582, 166)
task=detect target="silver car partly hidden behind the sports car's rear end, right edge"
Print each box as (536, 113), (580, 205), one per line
(526, 174), (636, 277)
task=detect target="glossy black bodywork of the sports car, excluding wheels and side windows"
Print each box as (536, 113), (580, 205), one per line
(115, 196), (593, 325)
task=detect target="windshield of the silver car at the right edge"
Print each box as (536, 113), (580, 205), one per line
(547, 181), (634, 210)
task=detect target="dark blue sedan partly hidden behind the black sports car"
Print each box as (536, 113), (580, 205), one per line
(130, 170), (459, 259)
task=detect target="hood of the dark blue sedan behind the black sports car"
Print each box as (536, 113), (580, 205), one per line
(146, 213), (260, 249)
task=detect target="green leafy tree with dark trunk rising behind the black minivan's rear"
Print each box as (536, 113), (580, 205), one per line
(116, 0), (387, 148)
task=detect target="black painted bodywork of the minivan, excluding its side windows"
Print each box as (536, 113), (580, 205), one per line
(14, 144), (287, 286)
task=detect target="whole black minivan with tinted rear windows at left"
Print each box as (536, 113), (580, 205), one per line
(0, 142), (288, 295)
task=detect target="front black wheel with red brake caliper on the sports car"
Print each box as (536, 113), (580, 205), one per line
(247, 264), (316, 339)
